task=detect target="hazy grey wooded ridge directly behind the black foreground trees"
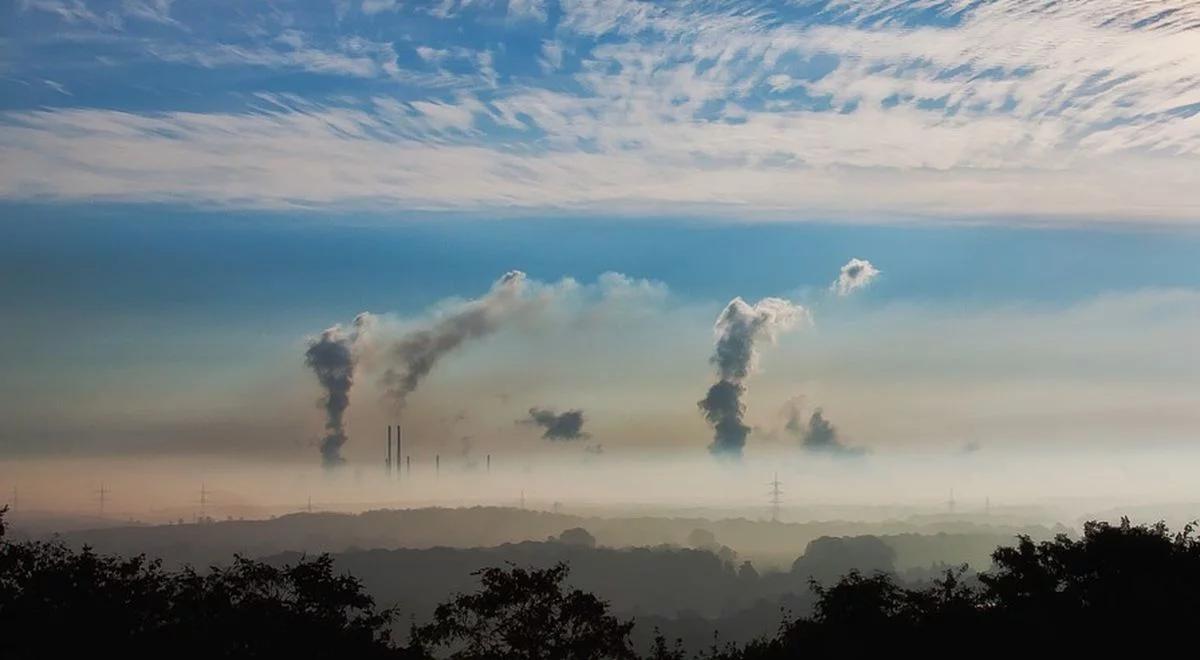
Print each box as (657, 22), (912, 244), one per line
(264, 528), (902, 644)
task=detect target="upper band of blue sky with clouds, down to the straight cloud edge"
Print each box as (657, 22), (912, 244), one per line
(0, 0), (1200, 224)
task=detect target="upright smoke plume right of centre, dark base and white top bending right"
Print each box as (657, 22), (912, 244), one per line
(697, 298), (809, 457)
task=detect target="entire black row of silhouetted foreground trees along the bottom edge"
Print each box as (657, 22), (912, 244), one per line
(0, 506), (1200, 660)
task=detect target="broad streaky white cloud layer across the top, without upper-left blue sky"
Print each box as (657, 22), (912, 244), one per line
(7, 0), (1200, 222)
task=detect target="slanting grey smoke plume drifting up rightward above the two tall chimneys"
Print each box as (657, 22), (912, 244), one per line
(383, 270), (526, 407)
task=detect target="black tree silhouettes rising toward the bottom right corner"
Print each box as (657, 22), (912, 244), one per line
(724, 520), (1200, 660)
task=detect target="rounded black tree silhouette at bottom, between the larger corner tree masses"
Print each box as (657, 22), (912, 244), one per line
(413, 563), (636, 660)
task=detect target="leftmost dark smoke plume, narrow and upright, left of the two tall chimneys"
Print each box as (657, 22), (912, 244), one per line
(305, 325), (354, 467)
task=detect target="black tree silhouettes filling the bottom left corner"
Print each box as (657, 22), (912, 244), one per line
(0, 511), (406, 659)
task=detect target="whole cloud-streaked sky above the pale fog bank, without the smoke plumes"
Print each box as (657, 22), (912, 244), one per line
(0, 0), (1200, 506)
